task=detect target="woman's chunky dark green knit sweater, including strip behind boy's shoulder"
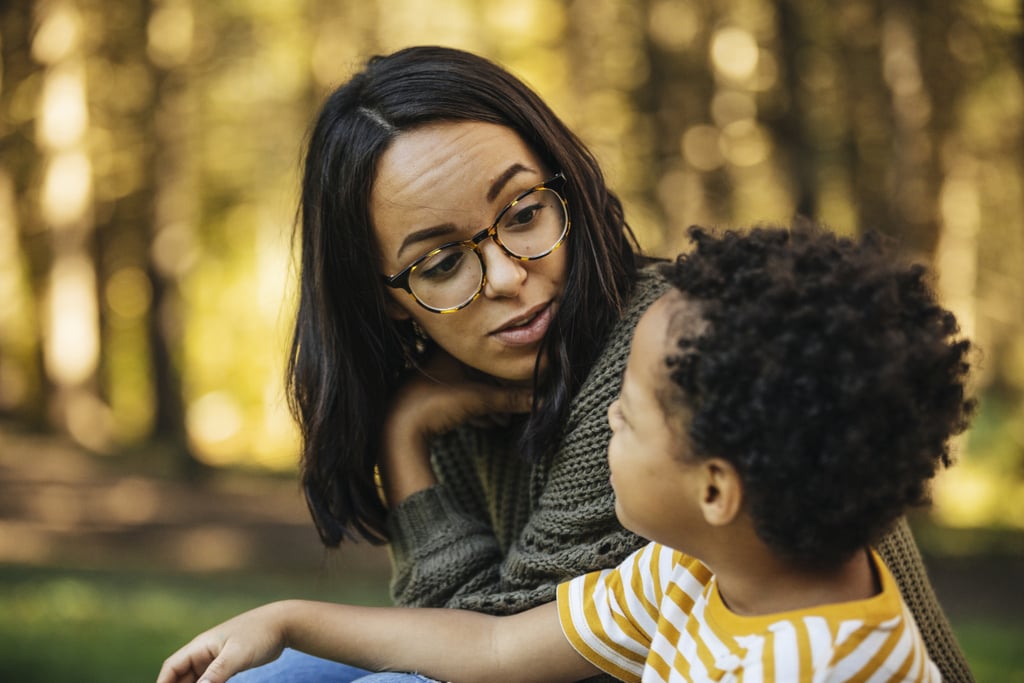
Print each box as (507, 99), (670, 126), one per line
(389, 268), (973, 683)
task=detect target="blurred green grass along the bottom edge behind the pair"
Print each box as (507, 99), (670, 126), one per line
(0, 567), (1024, 683)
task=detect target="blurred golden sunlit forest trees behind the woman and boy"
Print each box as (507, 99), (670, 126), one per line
(0, 0), (1024, 680)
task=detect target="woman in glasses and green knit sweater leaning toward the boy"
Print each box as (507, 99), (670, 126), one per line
(232, 47), (970, 682)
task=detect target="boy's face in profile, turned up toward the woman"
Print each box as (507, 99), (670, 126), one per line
(608, 290), (703, 550)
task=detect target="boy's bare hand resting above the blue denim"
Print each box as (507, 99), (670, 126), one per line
(157, 604), (285, 683)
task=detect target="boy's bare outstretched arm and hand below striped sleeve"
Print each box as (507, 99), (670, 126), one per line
(157, 600), (600, 683)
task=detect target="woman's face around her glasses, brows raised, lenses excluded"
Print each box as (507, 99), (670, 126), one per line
(370, 122), (571, 382)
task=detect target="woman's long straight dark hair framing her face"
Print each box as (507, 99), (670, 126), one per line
(288, 46), (636, 546)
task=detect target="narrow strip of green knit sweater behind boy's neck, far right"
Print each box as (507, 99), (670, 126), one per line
(879, 517), (974, 683)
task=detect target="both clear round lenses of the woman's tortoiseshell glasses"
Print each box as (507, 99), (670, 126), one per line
(409, 187), (568, 310)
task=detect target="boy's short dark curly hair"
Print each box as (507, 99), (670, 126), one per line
(664, 221), (974, 567)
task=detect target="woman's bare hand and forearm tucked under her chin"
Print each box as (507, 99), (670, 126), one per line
(380, 348), (532, 507)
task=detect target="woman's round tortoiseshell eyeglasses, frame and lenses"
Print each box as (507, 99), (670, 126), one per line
(384, 173), (570, 313)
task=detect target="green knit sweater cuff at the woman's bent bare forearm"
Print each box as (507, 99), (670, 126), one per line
(388, 484), (476, 564)
